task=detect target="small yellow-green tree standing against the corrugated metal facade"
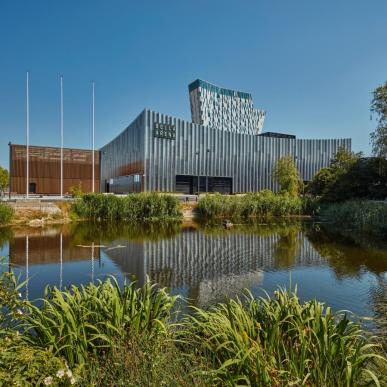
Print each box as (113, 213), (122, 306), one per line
(273, 156), (302, 196)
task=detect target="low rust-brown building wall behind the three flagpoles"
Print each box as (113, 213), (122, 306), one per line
(10, 145), (100, 195)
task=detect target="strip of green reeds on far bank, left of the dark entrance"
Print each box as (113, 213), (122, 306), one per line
(72, 192), (182, 221)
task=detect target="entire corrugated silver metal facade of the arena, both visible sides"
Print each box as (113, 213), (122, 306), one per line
(101, 110), (351, 193)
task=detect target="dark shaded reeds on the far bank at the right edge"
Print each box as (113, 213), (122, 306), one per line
(320, 200), (387, 238)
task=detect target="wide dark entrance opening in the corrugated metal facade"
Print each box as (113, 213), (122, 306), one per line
(176, 175), (232, 195)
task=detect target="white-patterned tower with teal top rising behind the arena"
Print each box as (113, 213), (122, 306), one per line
(188, 79), (265, 134)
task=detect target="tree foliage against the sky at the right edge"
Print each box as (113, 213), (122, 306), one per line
(371, 82), (387, 158)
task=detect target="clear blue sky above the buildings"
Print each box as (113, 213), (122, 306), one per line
(0, 0), (387, 166)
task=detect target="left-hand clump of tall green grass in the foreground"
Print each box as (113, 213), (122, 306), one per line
(21, 279), (176, 366)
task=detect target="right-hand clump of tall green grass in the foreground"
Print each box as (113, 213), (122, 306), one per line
(182, 289), (385, 386)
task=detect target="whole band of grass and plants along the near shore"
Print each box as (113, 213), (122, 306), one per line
(0, 274), (385, 386)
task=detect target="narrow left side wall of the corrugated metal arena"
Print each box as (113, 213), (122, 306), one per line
(100, 110), (145, 192)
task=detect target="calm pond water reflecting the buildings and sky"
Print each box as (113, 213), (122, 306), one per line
(0, 223), (387, 334)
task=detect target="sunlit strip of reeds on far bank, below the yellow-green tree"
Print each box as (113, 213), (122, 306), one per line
(197, 190), (309, 218)
